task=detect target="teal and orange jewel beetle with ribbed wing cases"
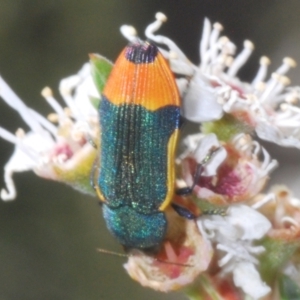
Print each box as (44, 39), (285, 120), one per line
(93, 40), (180, 250)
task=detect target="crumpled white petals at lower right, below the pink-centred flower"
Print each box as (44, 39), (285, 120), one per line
(198, 205), (271, 299)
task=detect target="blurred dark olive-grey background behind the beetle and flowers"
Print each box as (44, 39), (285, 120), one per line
(0, 0), (300, 300)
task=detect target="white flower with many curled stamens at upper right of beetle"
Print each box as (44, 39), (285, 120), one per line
(122, 13), (300, 148)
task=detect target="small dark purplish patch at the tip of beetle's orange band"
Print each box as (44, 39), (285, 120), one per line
(125, 42), (158, 64)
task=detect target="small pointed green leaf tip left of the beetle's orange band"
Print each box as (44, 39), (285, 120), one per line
(90, 54), (113, 95)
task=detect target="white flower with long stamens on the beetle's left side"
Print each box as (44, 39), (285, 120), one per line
(0, 64), (99, 200)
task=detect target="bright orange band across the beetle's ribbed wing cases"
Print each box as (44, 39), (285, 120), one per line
(103, 50), (180, 111)
